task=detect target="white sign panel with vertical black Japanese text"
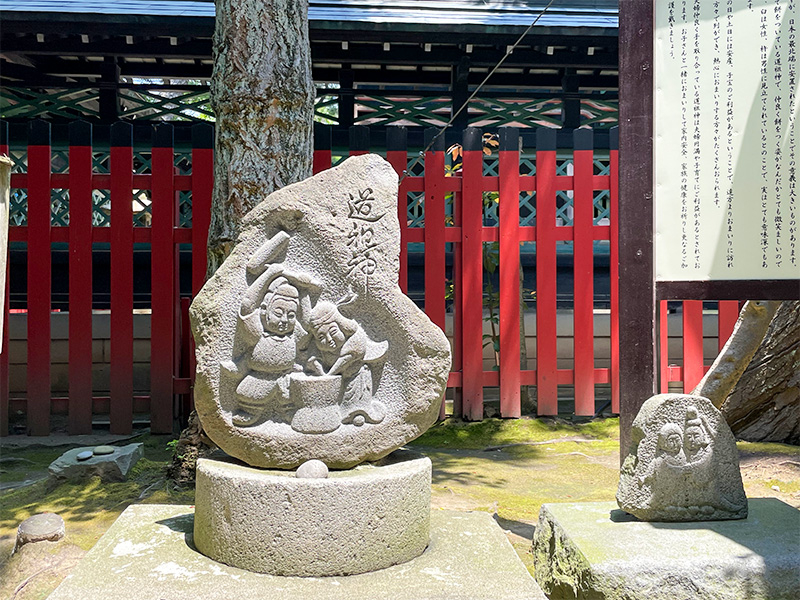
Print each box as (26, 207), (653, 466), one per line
(653, 0), (800, 282)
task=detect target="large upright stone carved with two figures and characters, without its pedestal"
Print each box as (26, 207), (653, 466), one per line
(190, 156), (450, 468)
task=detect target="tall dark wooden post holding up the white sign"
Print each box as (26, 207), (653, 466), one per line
(619, 0), (657, 460)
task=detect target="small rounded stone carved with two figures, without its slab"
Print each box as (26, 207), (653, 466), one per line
(617, 394), (747, 521)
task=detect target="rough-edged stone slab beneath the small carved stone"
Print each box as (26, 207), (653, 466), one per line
(533, 498), (800, 600)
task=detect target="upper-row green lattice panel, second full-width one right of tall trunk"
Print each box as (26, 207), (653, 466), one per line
(469, 98), (562, 128)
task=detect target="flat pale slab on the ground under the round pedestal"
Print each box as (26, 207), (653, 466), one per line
(49, 504), (546, 600)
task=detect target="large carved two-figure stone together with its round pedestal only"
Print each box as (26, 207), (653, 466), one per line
(190, 155), (450, 576)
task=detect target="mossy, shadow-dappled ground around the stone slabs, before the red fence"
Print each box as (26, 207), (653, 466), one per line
(0, 419), (800, 592)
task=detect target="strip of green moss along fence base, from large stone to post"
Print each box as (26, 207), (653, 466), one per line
(411, 419), (619, 450)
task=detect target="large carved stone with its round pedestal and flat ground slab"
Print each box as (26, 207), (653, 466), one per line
(43, 155), (544, 600)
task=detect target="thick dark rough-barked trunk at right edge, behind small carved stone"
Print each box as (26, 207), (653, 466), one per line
(722, 301), (800, 445)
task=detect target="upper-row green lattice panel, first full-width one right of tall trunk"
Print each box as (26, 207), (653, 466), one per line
(355, 94), (452, 127)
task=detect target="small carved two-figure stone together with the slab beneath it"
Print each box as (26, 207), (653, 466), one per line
(532, 394), (800, 600)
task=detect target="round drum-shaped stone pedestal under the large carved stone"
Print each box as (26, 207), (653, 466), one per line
(194, 451), (431, 577)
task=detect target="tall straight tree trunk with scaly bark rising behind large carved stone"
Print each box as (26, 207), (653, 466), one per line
(208, 0), (315, 275)
